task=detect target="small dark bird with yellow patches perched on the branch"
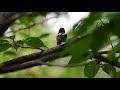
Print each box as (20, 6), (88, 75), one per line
(56, 27), (67, 45)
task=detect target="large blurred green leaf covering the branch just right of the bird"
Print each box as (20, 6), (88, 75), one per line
(67, 36), (91, 63)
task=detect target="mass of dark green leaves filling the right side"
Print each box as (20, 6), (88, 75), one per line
(65, 12), (120, 77)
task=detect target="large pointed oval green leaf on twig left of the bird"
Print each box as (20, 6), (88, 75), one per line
(25, 37), (45, 48)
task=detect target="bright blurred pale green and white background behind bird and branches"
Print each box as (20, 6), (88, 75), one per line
(0, 12), (109, 78)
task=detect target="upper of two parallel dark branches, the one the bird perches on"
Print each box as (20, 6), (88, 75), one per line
(0, 45), (64, 68)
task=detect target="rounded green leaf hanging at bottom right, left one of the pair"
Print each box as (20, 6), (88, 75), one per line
(84, 61), (100, 78)
